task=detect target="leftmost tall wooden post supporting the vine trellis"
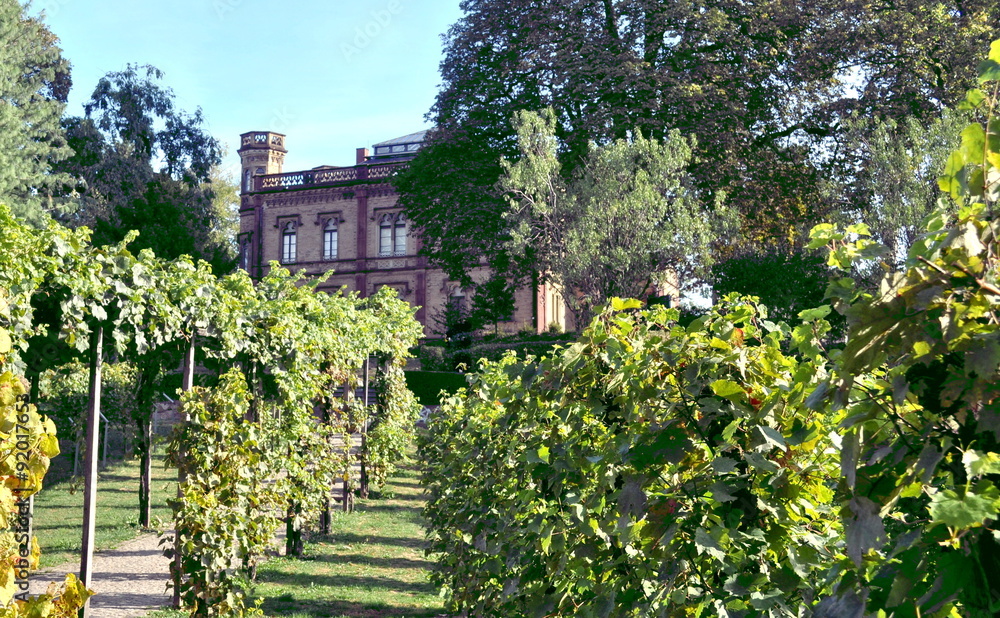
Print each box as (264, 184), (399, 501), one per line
(80, 326), (104, 618)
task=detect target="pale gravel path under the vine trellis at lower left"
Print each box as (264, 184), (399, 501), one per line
(31, 534), (173, 618)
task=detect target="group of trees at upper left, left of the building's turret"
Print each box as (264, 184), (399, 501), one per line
(0, 0), (238, 273)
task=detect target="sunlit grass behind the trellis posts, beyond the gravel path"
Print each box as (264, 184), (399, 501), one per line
(34, 442), (177, 567)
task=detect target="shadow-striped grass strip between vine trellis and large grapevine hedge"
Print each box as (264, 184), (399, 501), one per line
(147, 454), (443, 618)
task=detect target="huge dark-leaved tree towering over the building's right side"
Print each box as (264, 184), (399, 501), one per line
(398, 0), (1000, 300)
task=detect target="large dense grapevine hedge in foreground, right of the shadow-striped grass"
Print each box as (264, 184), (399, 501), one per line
(420, 296), (844, 616)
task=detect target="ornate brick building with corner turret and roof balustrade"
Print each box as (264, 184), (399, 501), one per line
(238, 131), (571, 337)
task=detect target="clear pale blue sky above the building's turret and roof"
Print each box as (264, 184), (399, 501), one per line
(31, 0), (461, 176)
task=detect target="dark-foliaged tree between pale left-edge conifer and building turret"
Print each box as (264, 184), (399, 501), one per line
(62, 65), (234, 271)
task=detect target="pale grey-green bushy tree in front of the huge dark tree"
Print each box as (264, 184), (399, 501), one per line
(500, 109), (728, 325)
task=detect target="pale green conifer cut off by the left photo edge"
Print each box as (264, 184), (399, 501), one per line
(0, 0), (71, 225)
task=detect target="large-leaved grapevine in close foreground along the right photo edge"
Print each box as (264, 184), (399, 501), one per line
(813, 42), (1000, 616)
